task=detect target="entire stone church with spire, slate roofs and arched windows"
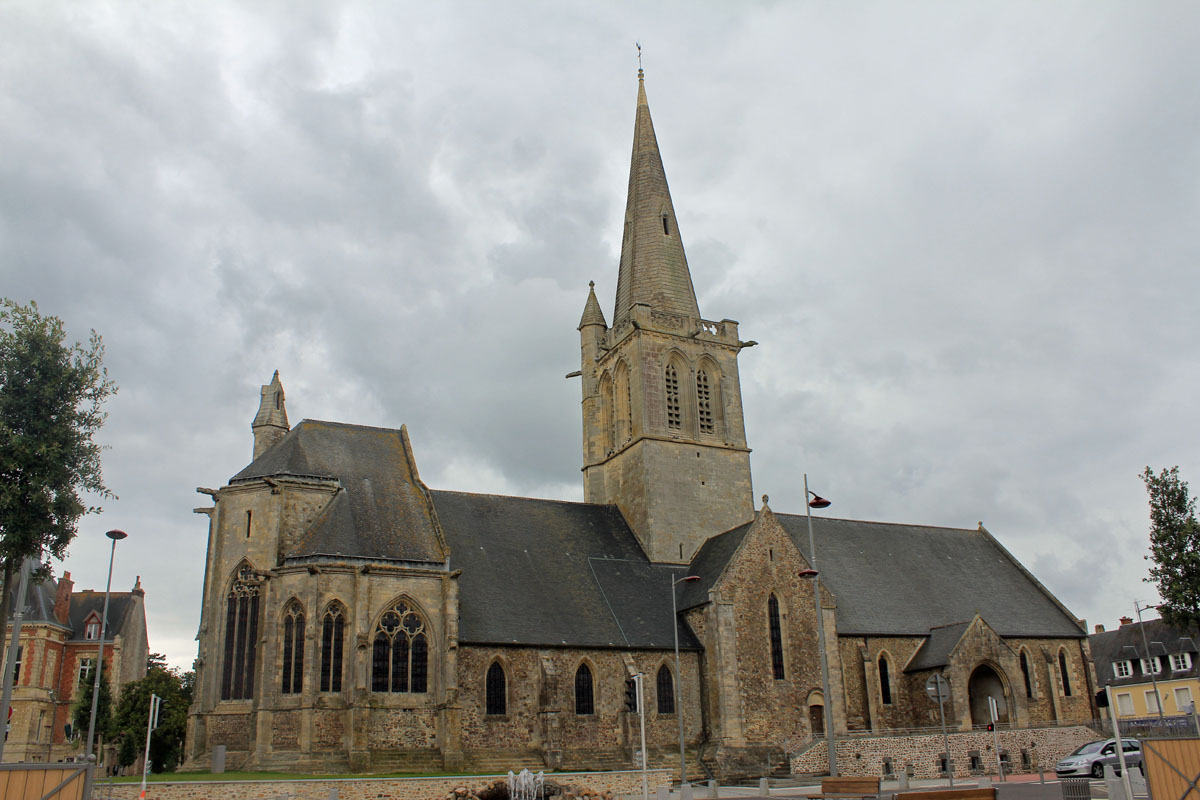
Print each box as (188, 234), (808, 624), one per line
(187, 73), (1096, 777)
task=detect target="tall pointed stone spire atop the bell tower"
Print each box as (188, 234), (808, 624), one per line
(613, 68), (700, 325)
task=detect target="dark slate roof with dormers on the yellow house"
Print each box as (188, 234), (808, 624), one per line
(1087, 619), (1200, 686)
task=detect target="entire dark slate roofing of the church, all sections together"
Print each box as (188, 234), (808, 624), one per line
(230, 420), (1086, 652)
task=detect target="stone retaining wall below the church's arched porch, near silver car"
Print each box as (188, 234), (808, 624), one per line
(792, 726), (1103, 778)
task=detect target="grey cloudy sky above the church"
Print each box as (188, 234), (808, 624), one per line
(0, 0), (1200, 666)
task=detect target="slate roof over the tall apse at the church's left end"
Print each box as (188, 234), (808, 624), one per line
(229, 420), (445, 563)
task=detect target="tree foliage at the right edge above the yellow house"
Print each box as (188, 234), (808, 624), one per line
(1141, 467), (1200, 630)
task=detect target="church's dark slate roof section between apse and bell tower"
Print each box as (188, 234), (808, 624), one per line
(431, 491), (700, 650)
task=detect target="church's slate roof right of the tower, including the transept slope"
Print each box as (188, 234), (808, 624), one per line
(682, 513), (1085, 638)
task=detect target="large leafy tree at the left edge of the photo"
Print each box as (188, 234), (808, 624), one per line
(0, 299), (116, 652)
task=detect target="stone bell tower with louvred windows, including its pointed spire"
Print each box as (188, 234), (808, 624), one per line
(578, 70), (754, 563)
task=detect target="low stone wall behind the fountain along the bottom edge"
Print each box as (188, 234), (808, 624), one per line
(97, 770), (673, 800)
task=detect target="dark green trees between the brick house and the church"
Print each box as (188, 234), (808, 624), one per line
(113, 667), (193, 772)
